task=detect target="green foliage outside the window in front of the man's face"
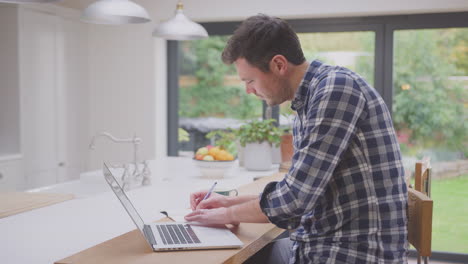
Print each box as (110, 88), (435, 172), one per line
(179, 36), (261, 119)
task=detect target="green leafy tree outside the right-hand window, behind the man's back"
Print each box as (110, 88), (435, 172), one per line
(393, 30), (467, 155)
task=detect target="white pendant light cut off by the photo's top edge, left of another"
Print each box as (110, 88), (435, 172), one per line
(81, 0), (151, 25)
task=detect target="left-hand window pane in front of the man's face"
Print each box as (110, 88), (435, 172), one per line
(178, 36), (262, 156)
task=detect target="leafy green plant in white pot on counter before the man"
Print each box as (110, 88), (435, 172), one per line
(236, 119), (281, 171)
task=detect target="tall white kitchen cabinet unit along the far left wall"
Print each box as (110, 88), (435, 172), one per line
(0, 5), (87, 189)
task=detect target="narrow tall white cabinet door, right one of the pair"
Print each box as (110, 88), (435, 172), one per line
(56, 18), (88, 182)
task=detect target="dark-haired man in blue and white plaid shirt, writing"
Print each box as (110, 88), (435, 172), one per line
(186, 15), (407, 263)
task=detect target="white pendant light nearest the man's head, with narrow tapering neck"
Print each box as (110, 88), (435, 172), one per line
(153, 2), (208, 40)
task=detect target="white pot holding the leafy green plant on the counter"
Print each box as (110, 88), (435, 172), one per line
(244, 142), (273, 171)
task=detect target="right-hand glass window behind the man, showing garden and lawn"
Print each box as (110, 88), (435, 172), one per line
(393, 28), (468, 253)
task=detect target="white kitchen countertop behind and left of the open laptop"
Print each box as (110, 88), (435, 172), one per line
(0, 157), (278, 264)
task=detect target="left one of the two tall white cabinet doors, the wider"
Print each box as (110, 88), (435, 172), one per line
(20, 9), (58, 187)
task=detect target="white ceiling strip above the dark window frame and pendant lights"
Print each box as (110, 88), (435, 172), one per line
(56, 0), (468, 22)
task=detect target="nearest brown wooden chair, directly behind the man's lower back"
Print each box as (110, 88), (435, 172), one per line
(408, 184), (433, 264)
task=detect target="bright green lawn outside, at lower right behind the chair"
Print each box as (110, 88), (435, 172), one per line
(431, 175), (468, 254)
